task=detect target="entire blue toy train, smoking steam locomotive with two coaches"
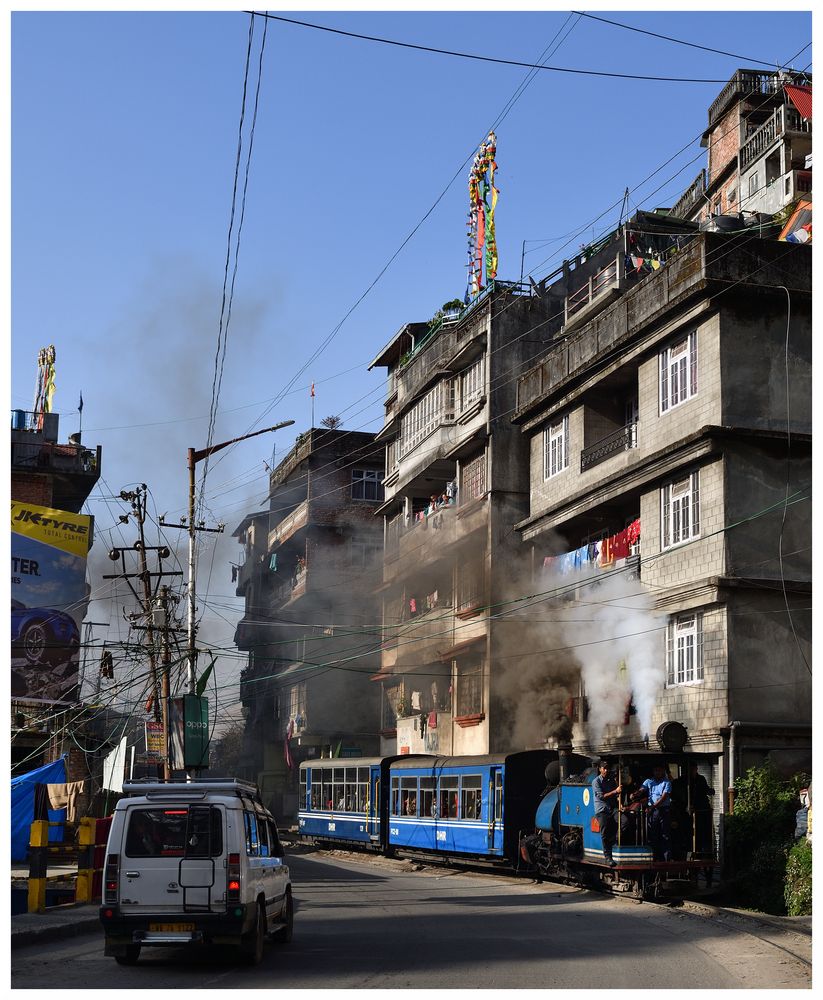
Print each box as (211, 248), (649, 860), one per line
(298, 732), (717, 898)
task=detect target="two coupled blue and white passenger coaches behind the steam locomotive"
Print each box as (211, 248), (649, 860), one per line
(298, 750), (587, 864)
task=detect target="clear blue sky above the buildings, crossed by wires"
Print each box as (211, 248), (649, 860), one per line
(11, 3), (811, 716)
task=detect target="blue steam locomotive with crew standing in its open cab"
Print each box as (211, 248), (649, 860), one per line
(520, 741), (718, 899)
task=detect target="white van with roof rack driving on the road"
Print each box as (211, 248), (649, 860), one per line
(100, 779), (294, 965)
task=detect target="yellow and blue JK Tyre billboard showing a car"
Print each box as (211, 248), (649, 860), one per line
(11, 500), (92, 703)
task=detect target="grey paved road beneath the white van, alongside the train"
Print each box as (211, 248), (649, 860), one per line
(11, 853), (810, 990)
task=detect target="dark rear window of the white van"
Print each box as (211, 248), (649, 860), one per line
(125, 805), (223, 858)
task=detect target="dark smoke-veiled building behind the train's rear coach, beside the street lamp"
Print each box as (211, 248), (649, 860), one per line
(234, 428), (383, 820)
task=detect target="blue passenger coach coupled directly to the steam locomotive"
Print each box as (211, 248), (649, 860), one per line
(386, 750), (557, 860)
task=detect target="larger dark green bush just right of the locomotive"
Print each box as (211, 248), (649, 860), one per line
(724, 761), (805, 913)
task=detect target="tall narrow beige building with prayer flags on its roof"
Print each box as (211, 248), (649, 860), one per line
(371, 282), (554, 754)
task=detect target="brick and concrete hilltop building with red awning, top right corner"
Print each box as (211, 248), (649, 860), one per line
(672, 69), (812, 227)
